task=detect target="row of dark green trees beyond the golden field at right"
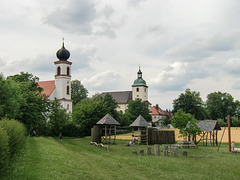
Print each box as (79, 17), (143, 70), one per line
(173, 89), (240, 126)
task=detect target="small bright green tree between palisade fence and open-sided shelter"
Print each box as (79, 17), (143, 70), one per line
(172, 109), (201, 142)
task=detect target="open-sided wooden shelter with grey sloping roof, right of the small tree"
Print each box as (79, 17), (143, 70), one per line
(197, 120), (221, 146)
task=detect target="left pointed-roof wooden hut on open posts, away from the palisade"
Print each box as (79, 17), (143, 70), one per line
(97, 114), (120, 144)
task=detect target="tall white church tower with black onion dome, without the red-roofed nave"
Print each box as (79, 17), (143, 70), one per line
(54, 41), (72, 112)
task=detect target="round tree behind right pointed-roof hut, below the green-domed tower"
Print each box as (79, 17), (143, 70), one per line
(124, 99), (152, 125)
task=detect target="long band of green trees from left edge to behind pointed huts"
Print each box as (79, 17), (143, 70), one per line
(0, 72), (151, 136)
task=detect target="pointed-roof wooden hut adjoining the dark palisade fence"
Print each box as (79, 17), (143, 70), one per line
(130, 115), (149, 145)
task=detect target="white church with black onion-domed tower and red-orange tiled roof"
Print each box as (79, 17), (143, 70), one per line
(38, 42), (73, 112)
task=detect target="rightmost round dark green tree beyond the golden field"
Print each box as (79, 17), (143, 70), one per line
(206, 92), (237, 121)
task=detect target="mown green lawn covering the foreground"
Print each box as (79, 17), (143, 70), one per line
(1, 137), (240, 180)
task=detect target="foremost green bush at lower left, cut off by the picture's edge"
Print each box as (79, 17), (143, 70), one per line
(0, 126), (10, 175)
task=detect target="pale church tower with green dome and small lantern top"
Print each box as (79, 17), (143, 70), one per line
(132, 67), (148, 101)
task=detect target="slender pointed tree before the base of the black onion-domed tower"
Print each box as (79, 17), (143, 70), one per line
(48, 98), (70, 136)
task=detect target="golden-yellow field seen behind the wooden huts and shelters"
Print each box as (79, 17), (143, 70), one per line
(117, 127), (240, 143)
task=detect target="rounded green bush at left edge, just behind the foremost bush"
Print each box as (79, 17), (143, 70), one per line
(0, 118), (26, 158)
